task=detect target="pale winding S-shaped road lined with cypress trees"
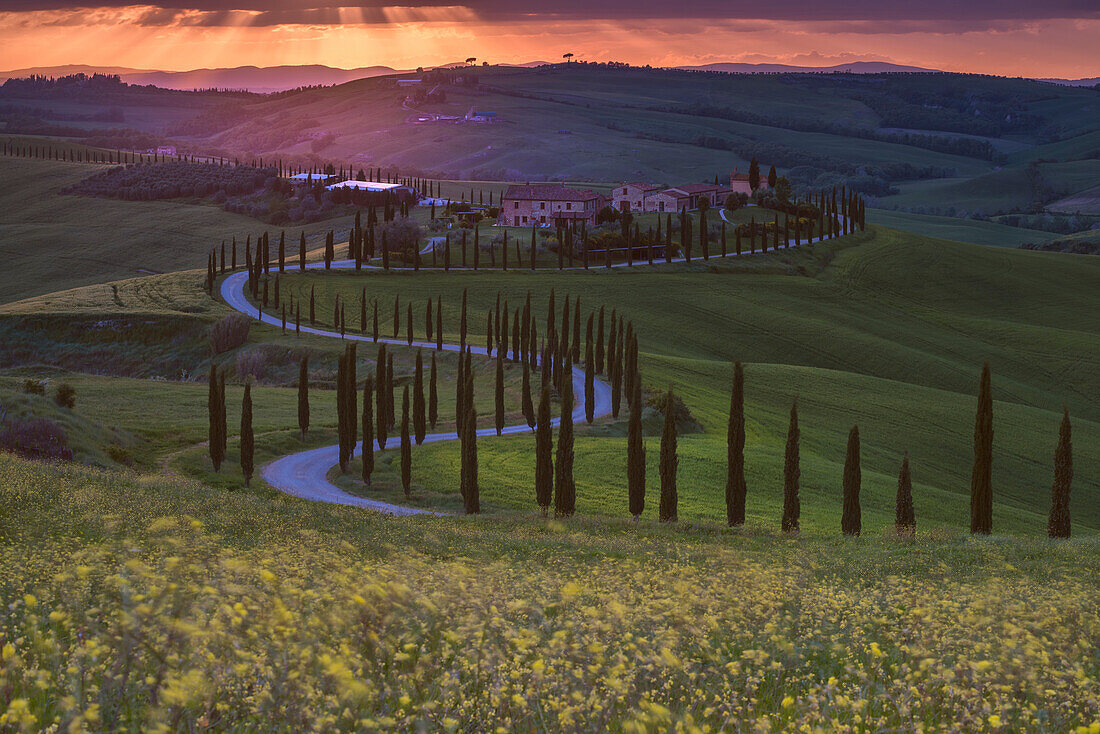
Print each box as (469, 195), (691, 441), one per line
(221, 268), (612, 515)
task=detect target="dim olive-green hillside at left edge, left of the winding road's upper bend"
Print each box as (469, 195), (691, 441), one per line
(0, 156), (354, 303)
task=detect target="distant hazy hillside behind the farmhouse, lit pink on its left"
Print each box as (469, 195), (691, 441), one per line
(198, 65), (1098, 182)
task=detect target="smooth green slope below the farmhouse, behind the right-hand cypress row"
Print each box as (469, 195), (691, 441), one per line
(216, 228), (1100, 533)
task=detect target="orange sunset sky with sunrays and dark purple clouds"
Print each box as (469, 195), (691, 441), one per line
(0, 0), (1100, 78)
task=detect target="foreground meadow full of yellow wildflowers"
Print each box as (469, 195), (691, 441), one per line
(0, 457), (1100, 732)
